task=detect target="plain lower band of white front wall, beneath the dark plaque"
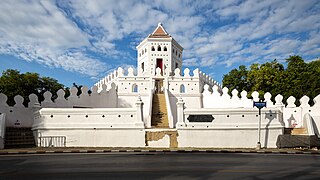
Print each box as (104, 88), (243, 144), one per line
(178, 128), (282, 148)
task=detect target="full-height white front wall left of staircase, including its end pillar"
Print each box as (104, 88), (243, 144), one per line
(32, 99), (145, 147)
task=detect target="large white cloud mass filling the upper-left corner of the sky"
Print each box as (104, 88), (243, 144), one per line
(0, 1), (106, 76)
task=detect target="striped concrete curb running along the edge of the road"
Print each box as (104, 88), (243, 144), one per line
(0, 149), (320, 155)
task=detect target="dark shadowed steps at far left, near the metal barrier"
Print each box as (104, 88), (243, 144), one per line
(4, 127), (35, 148)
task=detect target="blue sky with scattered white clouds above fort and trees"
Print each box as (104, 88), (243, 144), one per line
(0, 0), (320, 87)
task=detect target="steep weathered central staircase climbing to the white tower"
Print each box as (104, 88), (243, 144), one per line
(151, 94), (169, 128)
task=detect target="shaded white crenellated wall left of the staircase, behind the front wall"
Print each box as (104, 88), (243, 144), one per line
(0, 84), (118, 127)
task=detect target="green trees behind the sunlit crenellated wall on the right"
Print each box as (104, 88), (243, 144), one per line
(222, 55), (320, 103)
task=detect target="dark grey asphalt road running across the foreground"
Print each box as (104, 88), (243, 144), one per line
(0, 153), (320, 180)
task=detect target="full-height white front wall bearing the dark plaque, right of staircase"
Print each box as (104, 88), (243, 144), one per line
(177, 108), (284, 148)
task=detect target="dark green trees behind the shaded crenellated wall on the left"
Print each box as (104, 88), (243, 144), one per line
(0, 69), (65, 106)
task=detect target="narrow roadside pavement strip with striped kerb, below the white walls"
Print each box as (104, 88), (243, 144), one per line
(0, 147), (320, 155)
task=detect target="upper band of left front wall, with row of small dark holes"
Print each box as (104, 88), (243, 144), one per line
(33, 108), (143, 129)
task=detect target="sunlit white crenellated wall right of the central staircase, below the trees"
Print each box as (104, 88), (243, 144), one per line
(202, 85), (320, 128)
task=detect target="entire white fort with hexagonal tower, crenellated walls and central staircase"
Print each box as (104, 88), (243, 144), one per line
(0, 23), (320, 148)
